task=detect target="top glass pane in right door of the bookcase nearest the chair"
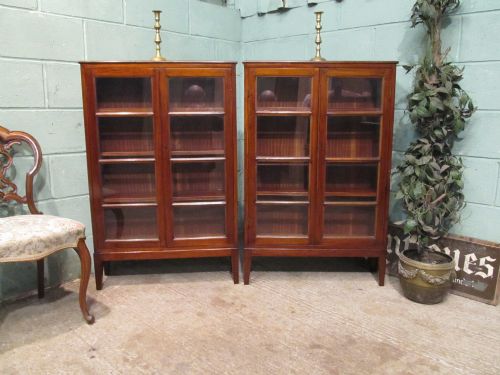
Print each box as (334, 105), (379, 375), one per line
(169, 77), (224, 112)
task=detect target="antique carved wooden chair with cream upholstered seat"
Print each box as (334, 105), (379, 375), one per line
(0, 126), (94, 324)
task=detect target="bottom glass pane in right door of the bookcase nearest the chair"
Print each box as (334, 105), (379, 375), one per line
(174, 204), (226, 238)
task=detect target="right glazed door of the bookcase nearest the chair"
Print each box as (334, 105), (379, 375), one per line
(161, 69), (236, 246)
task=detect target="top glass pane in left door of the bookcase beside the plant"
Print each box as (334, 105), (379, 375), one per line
(257, 77), (311, 111)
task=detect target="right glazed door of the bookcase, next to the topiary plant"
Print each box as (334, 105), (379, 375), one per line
(317, 68), (392, 248)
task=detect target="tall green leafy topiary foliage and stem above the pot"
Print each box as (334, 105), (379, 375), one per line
(396, 0), (475, 249)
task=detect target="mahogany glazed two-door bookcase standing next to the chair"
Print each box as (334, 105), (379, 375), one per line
(81, 62), (239, 289)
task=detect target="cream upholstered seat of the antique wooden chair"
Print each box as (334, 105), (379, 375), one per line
(0, 215), (85, 262)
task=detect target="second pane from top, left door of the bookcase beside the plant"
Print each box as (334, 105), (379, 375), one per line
(257, 116), (309, 157)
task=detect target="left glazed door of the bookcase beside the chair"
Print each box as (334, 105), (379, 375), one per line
(86, 69), (162, 248)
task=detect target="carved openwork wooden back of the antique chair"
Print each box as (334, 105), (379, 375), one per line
(0, 126), (42, 214)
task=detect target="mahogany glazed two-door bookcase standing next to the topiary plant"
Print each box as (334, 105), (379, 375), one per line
(243, 62), (396, 285)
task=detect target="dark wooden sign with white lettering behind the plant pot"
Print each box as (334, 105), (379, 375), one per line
(387, 225), (500, 305)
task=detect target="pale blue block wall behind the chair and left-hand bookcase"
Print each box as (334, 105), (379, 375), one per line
(0, 0), (241, 301)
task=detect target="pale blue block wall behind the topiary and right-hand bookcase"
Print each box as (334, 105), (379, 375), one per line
(239, 0), (500, 242)
